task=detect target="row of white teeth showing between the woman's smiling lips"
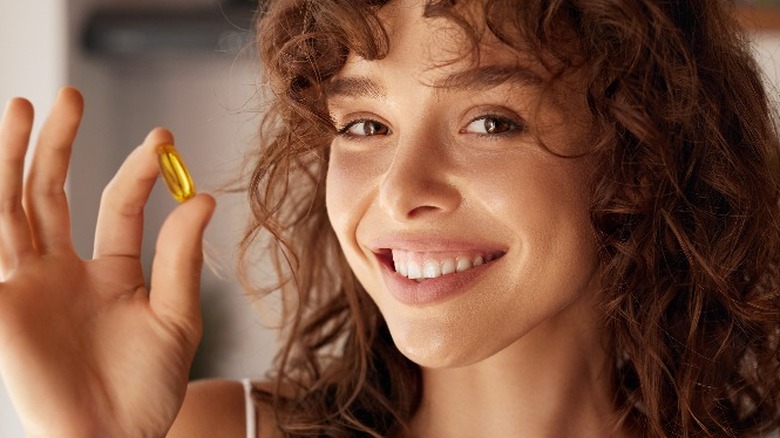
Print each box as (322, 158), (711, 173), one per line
(378, 249), (506, 282)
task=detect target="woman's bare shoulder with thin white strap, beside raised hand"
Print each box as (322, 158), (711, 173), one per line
(167, 379), (278, 438)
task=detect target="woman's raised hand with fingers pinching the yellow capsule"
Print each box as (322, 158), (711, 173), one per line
(0, 88), (214, 437)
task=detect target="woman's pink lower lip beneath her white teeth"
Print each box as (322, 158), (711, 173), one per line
(382, 260), (499, 306)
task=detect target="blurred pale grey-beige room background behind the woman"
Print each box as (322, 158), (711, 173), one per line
(0, 0), (780, 438)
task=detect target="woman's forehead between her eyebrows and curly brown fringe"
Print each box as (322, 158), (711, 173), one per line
(326, 0), (568, 101)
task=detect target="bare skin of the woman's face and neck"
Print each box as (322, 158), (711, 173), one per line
(327, 0), (632, 437)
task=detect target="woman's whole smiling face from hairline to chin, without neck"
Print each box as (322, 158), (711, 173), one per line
(327, 0), (598, 367)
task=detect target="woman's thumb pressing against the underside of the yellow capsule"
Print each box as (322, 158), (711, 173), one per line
(149, 194), (216, 343)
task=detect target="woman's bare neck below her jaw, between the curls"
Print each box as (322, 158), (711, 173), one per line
(411, 290), (624, 438)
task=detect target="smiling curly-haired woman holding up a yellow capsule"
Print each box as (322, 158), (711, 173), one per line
(0, 0), (780, 437)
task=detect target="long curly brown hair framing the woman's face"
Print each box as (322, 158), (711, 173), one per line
(241, 0), (780, 437)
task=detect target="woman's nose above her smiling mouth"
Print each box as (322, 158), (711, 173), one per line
(379, 129), (462, 222)
